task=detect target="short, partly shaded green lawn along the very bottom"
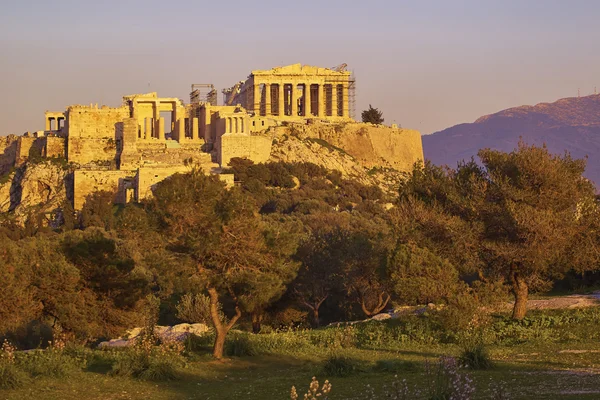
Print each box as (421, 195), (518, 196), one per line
(0, 342), (600, 400)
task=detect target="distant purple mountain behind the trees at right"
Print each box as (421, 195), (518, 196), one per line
(423, 95), (600, 187)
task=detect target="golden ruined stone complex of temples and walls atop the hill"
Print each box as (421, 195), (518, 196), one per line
(0, 64), (422, 209)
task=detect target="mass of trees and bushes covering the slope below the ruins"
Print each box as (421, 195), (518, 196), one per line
(0, 144), (600, 396)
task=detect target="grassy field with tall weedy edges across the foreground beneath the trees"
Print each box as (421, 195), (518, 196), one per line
(0, 309), (600, 400)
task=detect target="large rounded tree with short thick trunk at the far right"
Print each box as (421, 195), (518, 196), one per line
(479, 142), (599, 319)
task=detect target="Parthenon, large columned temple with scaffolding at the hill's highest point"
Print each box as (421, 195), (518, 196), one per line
(223, 64), (354, 120)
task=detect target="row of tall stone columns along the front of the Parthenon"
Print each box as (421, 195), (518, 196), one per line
(252, 82), (349, 117)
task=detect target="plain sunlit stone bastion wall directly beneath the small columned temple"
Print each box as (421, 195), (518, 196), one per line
(215, 134), (272, 167)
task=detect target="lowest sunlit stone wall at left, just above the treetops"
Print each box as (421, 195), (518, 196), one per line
(73, 170), (134, 210)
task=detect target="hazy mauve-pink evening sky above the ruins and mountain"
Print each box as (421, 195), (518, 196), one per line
(0, 0), (600, 135)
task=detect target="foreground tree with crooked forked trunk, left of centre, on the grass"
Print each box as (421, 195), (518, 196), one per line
(147, 170), (296, 359)
